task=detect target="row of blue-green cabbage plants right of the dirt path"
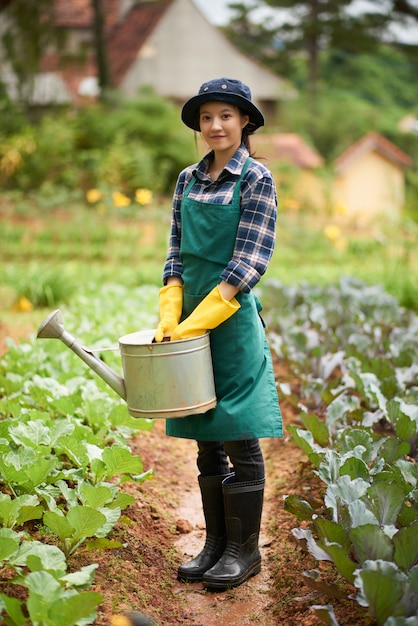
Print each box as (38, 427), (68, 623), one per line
(264, 279), (418, 626)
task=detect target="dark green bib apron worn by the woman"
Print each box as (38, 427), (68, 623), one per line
(166, 158), (283, 441)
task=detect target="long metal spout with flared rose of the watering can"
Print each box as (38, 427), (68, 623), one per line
(36, 309), (126, 400)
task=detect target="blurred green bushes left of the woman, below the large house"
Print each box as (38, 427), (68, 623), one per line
(0, 90), (196, 196)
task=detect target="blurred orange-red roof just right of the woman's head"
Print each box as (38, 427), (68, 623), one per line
(251, 133), (323, 169)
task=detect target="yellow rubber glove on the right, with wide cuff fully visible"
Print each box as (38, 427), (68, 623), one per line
(171, 285), (241, 341)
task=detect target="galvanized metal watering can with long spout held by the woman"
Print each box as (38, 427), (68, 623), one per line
(37, 309), (216, 418)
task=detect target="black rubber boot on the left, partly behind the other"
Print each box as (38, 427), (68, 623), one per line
(177, 474), (230, 583)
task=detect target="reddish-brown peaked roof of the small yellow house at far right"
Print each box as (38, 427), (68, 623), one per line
(335, 132), (412, 172)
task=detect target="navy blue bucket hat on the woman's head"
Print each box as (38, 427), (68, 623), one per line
(181, 78), (264, 133)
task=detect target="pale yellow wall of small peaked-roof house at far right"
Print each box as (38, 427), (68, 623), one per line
(332, 152), (404, 222)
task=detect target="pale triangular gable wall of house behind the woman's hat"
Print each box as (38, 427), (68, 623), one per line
(120, 0), (293, 104)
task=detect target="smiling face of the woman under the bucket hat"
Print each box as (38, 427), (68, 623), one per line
(199, 102), (250, 156)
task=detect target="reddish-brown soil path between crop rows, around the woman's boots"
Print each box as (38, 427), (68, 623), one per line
(0, 325), (374, 626)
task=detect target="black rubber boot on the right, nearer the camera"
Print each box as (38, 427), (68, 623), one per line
(203, 477), (265, 589)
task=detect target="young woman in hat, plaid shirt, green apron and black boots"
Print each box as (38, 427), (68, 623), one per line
(156, 78), (282, 589)
